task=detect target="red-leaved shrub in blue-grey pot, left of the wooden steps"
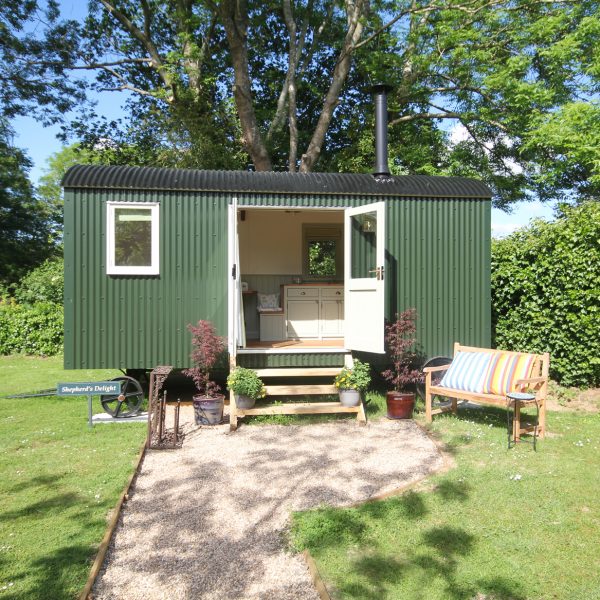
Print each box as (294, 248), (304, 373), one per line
(183, 320), (225, 425)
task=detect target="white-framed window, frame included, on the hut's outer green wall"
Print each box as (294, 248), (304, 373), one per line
(106, 202), (160, 275)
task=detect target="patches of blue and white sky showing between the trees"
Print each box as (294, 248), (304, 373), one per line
(12, 0), (553, 237)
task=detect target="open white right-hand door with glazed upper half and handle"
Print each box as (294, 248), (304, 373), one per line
(344, 202), (385, 354)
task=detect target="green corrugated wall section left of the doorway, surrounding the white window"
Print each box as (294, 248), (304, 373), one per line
(64, 190), (227, 368)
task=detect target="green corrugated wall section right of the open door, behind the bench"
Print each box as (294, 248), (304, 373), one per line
(386, 198), (491, 356)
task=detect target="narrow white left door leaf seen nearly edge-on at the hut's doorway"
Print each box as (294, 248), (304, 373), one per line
(227, 198), (246, 358)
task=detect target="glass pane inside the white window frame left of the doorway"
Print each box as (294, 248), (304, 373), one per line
(115, 208), (152, 267)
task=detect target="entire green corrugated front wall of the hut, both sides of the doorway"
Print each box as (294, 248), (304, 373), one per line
(64, 189), (491, 368)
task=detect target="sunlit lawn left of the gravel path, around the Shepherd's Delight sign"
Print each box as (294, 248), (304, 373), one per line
(0, 357), (146, 600)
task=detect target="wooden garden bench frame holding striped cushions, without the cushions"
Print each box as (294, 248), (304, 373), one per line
(423, 342), (550, 440)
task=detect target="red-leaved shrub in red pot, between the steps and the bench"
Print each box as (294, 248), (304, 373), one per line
(381, 308), (423, 419)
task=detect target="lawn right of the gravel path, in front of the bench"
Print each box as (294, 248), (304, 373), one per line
(292, 408), (600, 600)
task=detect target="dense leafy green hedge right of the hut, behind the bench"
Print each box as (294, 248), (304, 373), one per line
(492, 201), (600, 386)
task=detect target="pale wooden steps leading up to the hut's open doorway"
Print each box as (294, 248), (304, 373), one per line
(229, 355), (367, 431)
